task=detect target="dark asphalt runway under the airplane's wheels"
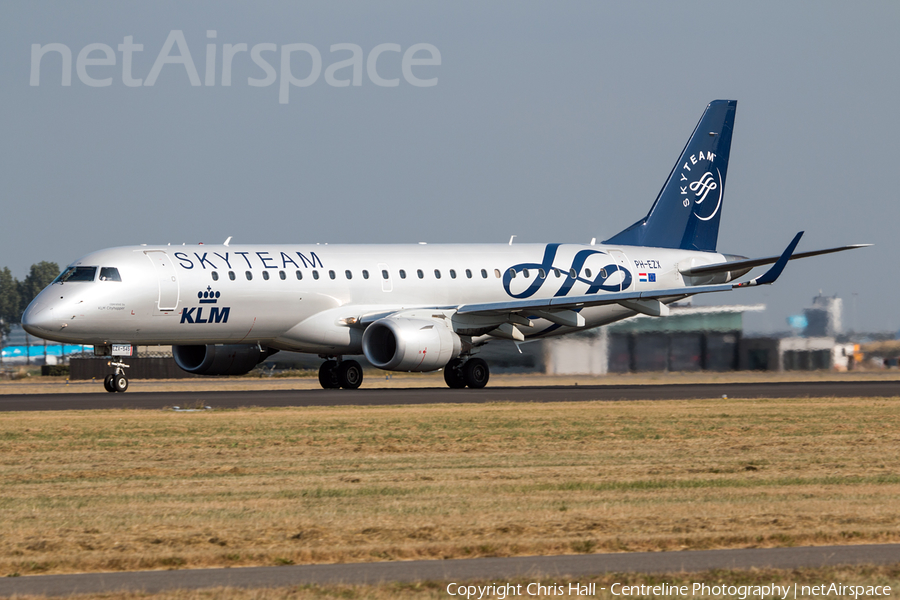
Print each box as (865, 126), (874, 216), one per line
(0, 380), (900, 412)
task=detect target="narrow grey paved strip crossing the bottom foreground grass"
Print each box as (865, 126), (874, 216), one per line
(0, 544), (900, 596)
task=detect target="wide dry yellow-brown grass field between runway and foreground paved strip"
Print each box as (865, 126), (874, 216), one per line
(0, 398), (900, 576)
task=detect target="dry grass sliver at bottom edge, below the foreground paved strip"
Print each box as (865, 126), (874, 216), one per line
(5, 565), (900, 600)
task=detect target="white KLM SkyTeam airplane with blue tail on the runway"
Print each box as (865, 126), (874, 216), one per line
(22, 100), (868, 392)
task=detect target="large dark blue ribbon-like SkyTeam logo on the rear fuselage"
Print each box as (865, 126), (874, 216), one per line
(503, 244), (633, 298)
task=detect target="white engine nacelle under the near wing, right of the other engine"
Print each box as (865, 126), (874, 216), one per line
(363, 317), (462, 371)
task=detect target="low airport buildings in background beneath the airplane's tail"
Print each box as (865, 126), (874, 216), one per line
(544, 293), (868, 375)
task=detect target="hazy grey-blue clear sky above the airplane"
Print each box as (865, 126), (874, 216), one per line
(0, 1), (900, 333)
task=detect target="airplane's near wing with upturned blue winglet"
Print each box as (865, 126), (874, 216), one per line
(456, 231), (803, 327)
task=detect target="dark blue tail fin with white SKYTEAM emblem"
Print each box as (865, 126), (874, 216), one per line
(603, 100), (737, 252)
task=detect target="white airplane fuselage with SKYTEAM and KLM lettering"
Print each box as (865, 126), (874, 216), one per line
(23, 244), (725, 355)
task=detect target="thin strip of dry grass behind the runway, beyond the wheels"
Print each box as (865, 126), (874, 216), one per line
(0, 369), (900, 396)
